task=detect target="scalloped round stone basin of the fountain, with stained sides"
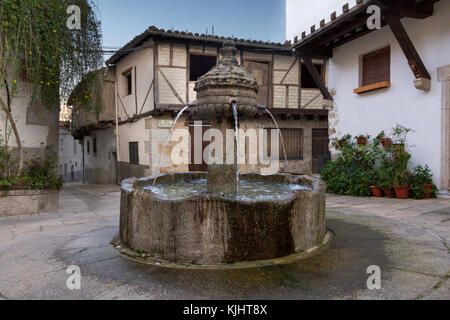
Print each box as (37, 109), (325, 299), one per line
(119, 172), (329, 266)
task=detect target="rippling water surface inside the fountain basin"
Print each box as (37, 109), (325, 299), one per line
(141, 179), (311, 201)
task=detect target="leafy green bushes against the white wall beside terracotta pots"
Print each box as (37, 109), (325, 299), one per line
(322, 125), (437, 199)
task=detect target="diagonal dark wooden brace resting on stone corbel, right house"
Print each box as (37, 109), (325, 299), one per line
(383, 8), (431, 79)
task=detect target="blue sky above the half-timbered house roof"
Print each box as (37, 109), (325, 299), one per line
(97, 0), (286, 52)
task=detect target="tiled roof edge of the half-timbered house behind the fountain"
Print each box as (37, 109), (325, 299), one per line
(106, 26), (291, 65)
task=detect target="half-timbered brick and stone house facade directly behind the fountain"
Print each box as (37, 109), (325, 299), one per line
(103, 27), (328, 181)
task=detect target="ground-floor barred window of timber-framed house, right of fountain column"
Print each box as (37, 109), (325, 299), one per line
(266, 128), (303, 160)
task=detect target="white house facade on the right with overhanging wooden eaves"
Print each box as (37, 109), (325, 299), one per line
(287, 0), (450, 190)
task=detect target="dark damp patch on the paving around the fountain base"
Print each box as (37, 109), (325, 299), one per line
(54, 217), (390, 299)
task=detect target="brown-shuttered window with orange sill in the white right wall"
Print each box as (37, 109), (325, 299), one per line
(361, 47), (391, 87)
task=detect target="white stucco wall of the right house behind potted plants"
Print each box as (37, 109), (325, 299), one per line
(287, 0), (450, 184)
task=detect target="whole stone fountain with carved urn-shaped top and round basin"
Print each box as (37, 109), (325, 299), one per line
(115, 41), (332, 268)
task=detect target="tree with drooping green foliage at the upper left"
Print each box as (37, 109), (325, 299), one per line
(0, 0), (103, 176)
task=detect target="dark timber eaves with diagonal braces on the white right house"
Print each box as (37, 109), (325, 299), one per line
(293, 0), (439, 84)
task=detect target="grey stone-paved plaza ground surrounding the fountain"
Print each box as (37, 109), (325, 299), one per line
(0, 184), (450, 300)
